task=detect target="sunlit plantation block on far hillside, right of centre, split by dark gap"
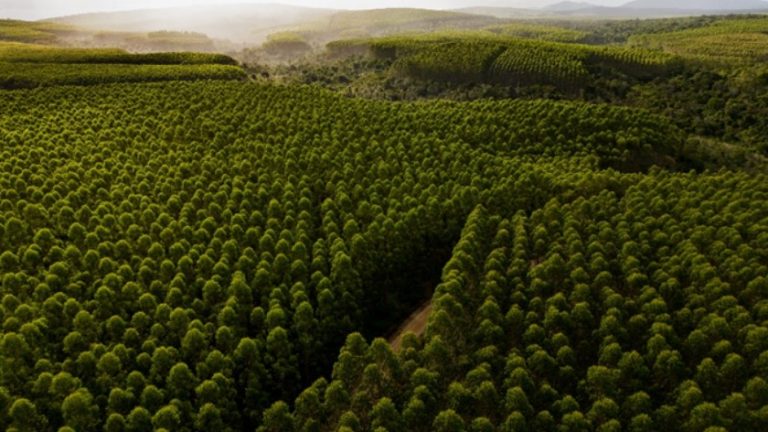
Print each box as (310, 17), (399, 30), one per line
(336, 32), (677, 91)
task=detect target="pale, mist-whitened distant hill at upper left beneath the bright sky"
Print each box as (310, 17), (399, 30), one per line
(47, 4), (336, 42)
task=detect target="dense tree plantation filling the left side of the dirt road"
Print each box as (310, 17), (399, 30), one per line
(0, 76), (678, 430)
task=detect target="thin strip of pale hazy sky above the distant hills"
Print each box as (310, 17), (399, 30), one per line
(0, 0), (629, 19)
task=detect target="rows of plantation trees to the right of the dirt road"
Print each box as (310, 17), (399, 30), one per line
(302, 169), (768, 431)
